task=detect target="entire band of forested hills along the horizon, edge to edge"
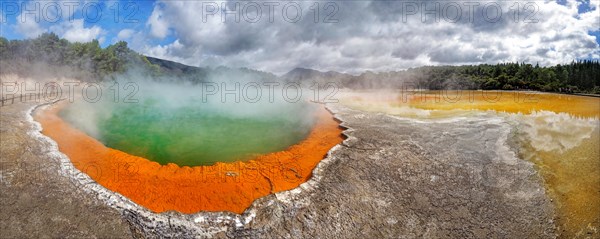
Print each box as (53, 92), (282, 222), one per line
(0, 33), (600, 94)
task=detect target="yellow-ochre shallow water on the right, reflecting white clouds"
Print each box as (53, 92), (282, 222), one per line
(341, 91), (600, 238)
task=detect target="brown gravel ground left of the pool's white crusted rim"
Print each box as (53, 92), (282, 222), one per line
(0, 103), (131, 238)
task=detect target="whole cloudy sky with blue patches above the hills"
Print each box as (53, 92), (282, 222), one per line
(0, 0), (600, 74)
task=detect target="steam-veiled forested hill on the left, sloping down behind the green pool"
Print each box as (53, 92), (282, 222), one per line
(0, 33), (276, 82)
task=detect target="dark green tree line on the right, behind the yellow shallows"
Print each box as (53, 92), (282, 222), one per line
(346, 60), (600, 94)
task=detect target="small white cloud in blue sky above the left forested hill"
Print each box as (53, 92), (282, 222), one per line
(50, 19), (104, 43)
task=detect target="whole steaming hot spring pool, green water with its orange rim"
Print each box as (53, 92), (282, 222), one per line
(34, 89), (344, 213)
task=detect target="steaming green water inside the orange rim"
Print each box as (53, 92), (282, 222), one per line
(60, 99), (314, 166)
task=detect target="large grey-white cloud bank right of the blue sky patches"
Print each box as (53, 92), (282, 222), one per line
(141, 0), (600, 73)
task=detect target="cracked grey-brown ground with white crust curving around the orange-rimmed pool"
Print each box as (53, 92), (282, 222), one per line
(0, 98), (556, 238)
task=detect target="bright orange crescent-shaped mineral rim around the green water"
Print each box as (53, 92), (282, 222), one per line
(34, 104), (344, 214)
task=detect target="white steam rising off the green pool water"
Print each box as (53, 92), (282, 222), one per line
(61, 71), (316, 160)
